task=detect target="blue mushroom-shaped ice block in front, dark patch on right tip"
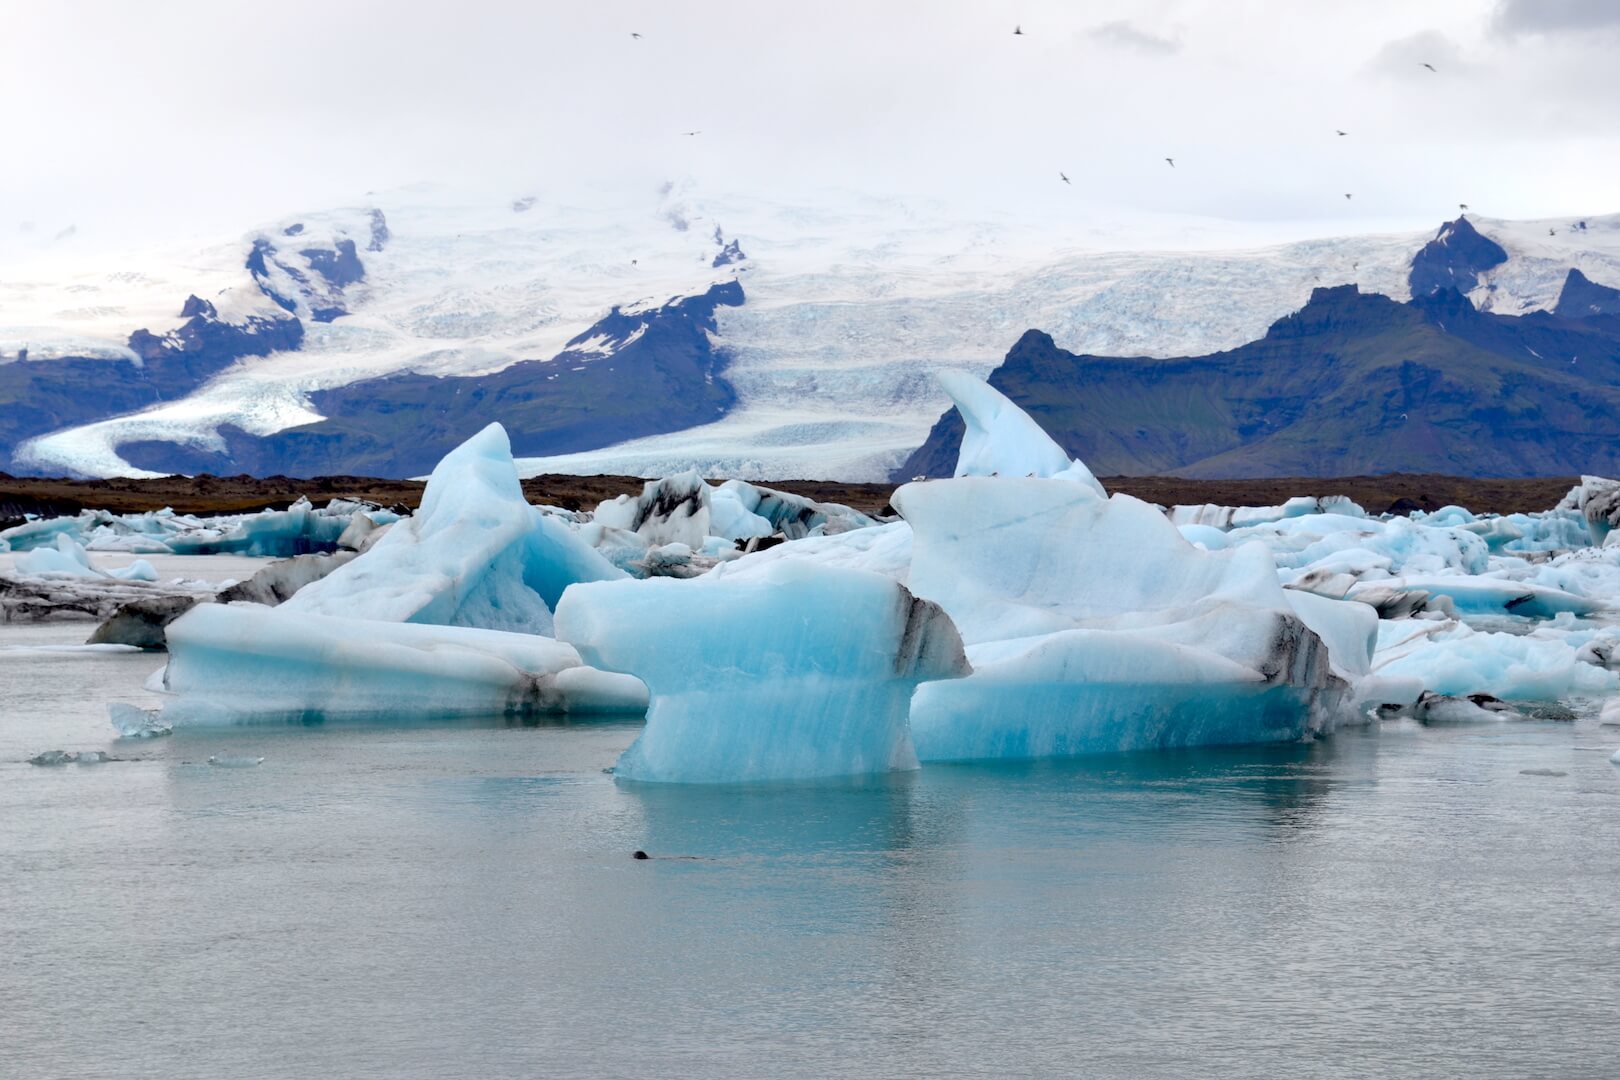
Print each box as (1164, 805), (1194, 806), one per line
(557, 560), (967, 784)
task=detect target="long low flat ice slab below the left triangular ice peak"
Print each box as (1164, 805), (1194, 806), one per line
(164, 604), (646, 725)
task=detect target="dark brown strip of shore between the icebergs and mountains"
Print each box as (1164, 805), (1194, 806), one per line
(0, 473), (1580, 526)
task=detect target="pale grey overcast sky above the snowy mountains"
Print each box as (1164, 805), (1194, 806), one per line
(0, 0), (1620, 253)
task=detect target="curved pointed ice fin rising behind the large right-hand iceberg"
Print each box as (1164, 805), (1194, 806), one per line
(938, 371), (1108, 499)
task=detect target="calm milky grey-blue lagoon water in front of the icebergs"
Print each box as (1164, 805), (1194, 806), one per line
(0, 627), (1620, 1078)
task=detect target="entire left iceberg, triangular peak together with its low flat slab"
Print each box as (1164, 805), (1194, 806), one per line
(162, 424), (646, 724)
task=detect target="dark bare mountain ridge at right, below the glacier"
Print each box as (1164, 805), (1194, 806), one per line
(894, 285), (1620, 478)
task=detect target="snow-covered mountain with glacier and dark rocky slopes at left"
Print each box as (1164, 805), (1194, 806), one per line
(0, 186), (1620, 479)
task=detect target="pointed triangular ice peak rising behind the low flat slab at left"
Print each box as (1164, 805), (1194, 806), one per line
(282, 424), (624, 633)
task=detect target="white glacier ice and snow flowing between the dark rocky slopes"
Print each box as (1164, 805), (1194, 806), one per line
(15, 188), (1620, 479)
